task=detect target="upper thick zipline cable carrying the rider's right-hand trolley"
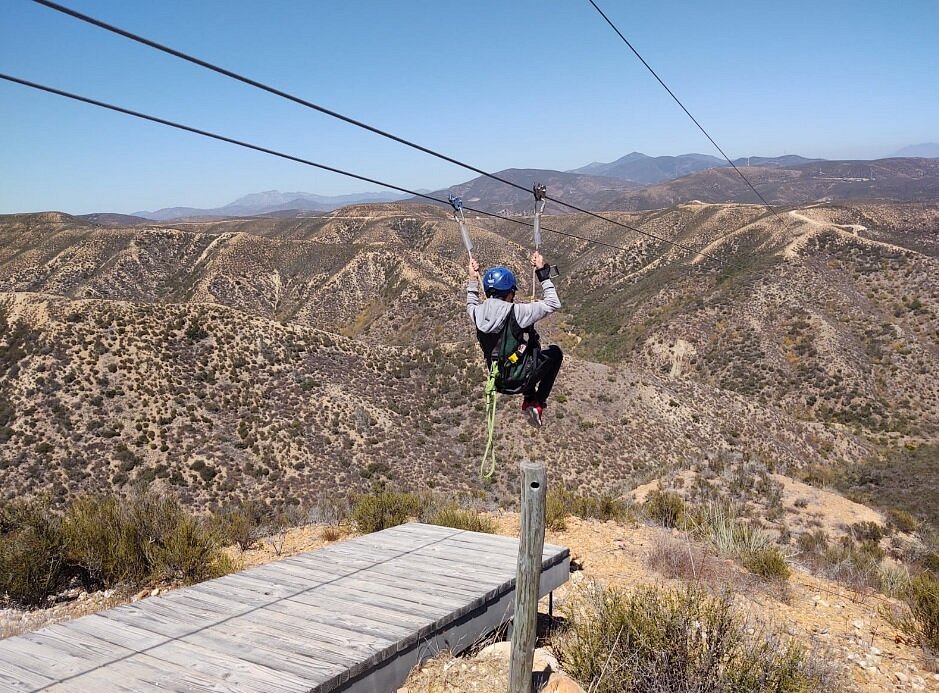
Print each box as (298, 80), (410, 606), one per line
(33, 0), (724, 265)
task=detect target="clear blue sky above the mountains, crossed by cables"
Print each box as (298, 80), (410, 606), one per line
(0, 0), (939, 214)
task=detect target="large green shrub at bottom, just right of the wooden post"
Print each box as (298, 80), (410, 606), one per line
(556, 586), (838, 693)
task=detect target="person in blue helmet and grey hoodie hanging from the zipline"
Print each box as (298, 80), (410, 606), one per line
(466, 252), (564, 425)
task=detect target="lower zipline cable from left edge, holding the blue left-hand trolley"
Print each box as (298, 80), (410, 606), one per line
(0, 73), (648, 252)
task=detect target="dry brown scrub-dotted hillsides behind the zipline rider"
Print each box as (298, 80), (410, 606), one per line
(0, 203), (939, 524)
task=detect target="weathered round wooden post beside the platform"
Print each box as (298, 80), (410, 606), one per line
(509, 462), (548, 693)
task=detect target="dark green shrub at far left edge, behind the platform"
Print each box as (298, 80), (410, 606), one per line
(0, 501), (70, 606)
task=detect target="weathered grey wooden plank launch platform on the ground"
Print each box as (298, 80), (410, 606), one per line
(0, 524), (570, 693)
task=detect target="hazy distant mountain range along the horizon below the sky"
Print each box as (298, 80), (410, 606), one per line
(126, 152), (939, 226)
